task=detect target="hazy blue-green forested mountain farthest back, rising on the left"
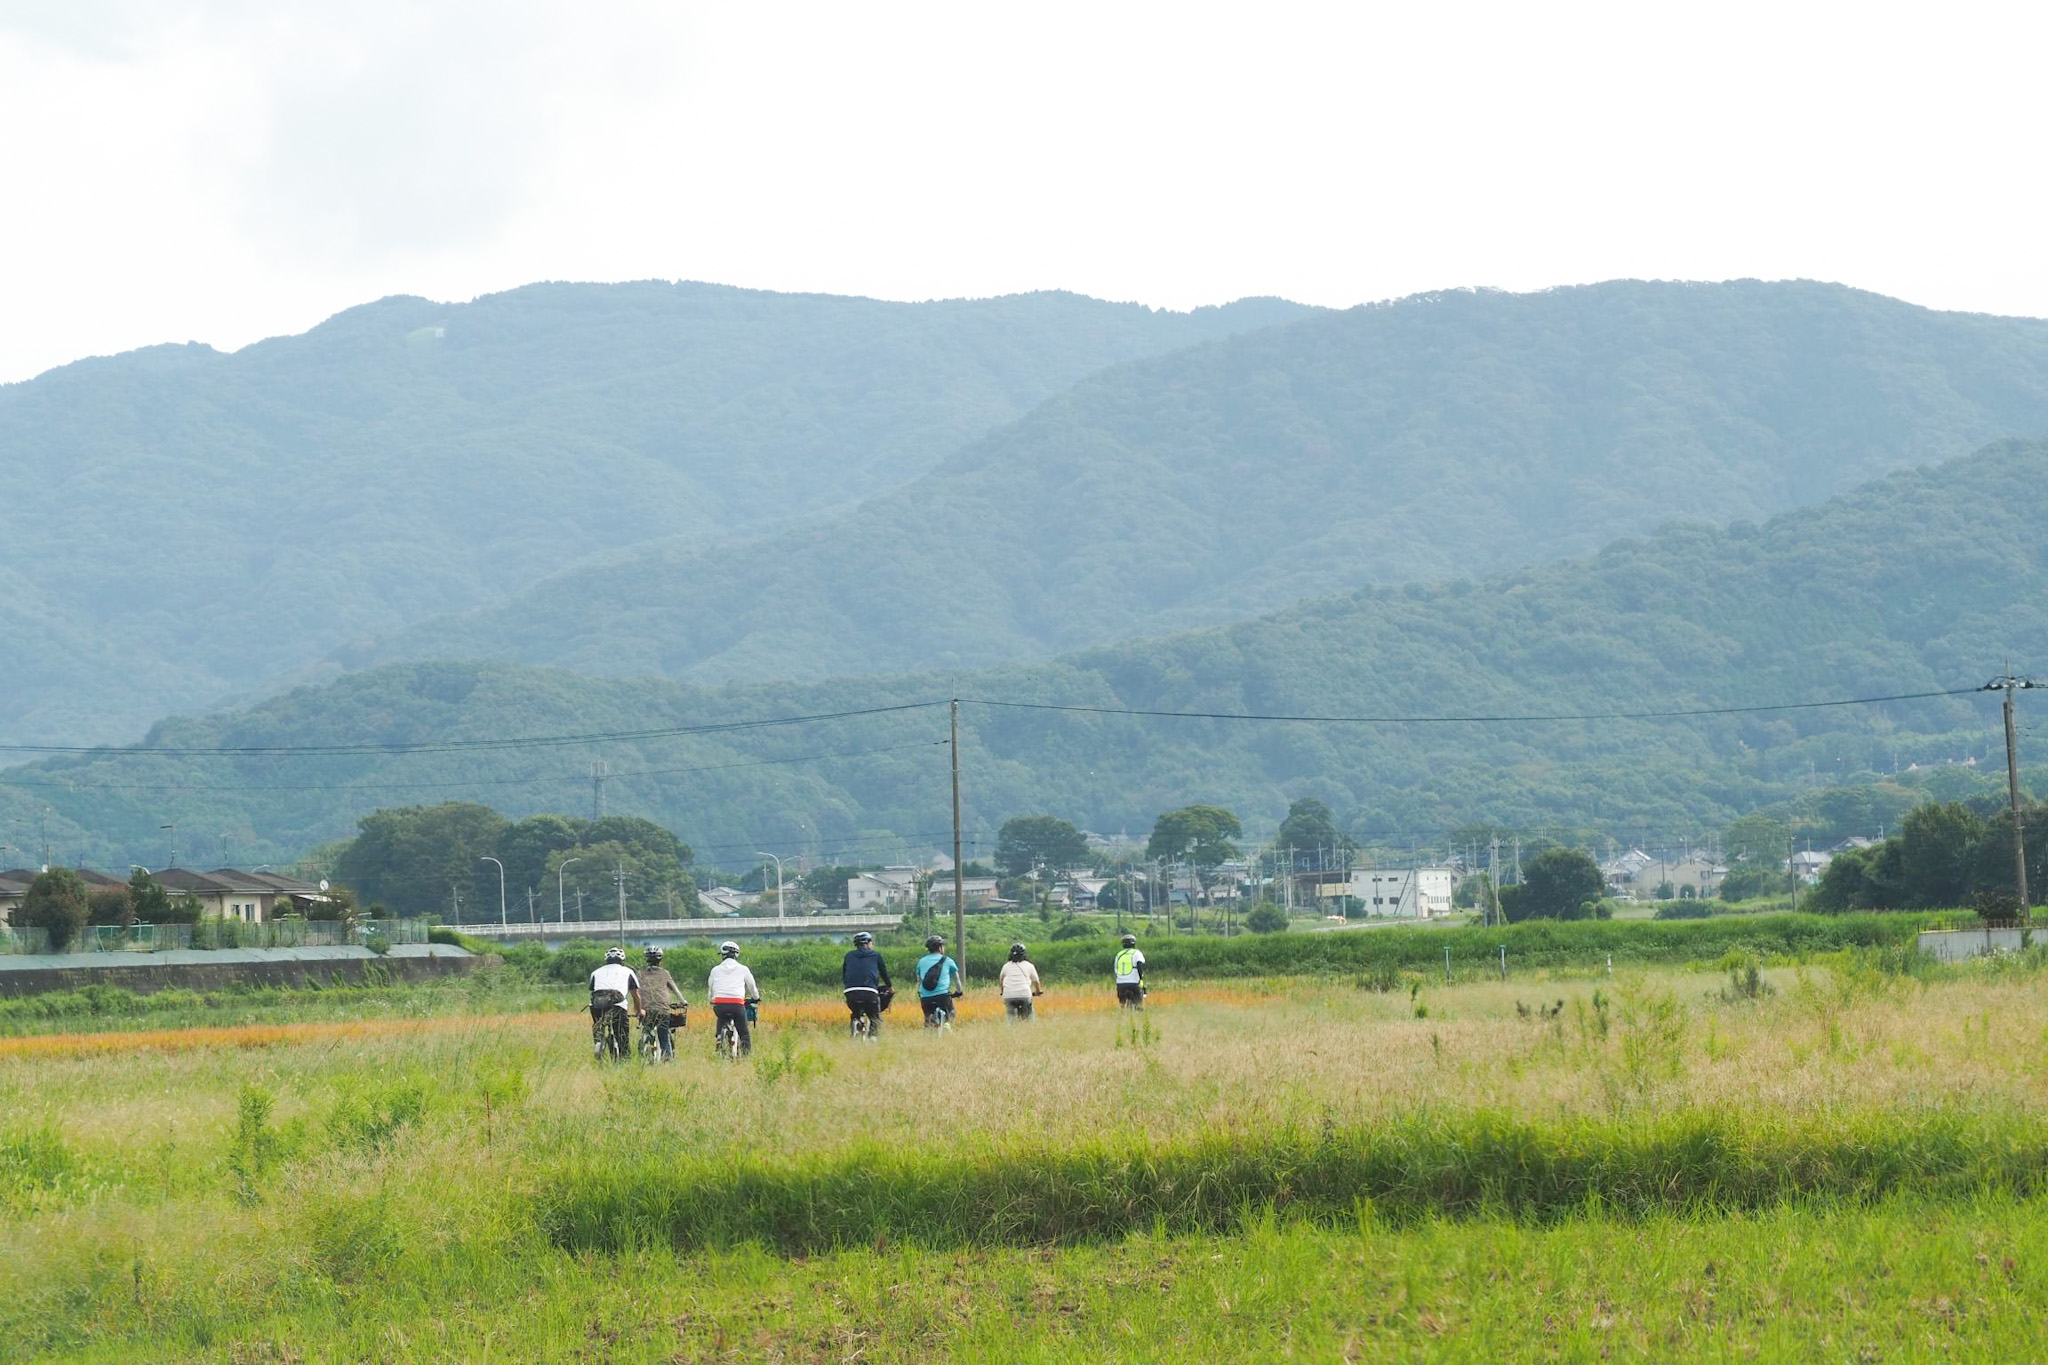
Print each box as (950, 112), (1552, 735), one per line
(0, 282), (1307, 741)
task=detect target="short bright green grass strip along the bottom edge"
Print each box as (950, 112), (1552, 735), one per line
(16, 1195), (2048, 1365)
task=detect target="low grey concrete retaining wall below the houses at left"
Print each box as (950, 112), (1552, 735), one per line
(0, 943), (483, 997)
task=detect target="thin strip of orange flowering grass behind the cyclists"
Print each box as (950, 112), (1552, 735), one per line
(0, 986), (1280, 1060)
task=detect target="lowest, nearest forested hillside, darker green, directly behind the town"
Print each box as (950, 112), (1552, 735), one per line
(19, 431), (2048, 866)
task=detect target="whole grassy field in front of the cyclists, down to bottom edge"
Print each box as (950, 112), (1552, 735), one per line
(0, 952), (2048, 1361)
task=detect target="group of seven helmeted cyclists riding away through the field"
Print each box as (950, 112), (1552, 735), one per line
(590, 929), (1145, 1062)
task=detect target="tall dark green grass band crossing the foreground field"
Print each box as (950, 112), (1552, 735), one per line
(535, 1111), (2048, 1254)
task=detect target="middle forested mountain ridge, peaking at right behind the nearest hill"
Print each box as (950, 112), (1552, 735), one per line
(372, 282), (2048, 681)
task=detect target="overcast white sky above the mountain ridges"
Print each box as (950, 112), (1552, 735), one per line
(0, 0), (2048, 381)
